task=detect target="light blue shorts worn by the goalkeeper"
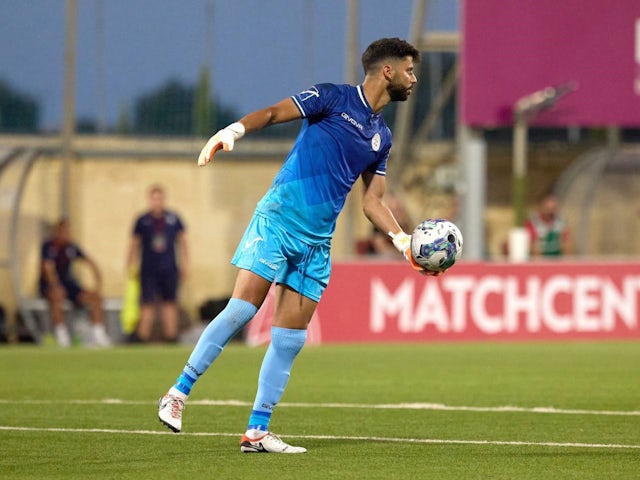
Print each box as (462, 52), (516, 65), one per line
(231, 213), (331, 302)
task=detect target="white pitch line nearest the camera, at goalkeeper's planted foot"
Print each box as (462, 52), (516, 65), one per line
(0, 425), (640, 450)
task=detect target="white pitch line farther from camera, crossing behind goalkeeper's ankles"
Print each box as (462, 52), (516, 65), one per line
(0, 398), (640, 417)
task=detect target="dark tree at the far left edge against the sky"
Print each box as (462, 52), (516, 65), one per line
(0, 79), (40, 133)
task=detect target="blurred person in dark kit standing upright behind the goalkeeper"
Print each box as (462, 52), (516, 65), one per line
(127, 185), (188, 342)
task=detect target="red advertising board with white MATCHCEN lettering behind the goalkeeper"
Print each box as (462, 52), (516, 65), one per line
(245, 262), (640, 345)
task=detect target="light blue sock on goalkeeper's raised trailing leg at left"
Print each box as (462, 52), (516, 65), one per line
(174, 298), (258, 395)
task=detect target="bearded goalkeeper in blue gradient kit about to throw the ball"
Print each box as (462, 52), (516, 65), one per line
(158, 38), (436, 453)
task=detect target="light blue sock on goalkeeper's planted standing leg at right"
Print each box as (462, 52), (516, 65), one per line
(247, 327), (307, 431)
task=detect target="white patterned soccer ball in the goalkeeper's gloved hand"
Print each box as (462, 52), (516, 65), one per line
(411, 218), (462, 272)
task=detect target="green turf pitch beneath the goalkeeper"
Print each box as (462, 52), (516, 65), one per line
(0, 342), (640, 480)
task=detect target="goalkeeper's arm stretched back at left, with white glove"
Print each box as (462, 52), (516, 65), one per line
(198, 98), (302, 166)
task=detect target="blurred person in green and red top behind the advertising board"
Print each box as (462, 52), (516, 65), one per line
(525, 193), (574, 257)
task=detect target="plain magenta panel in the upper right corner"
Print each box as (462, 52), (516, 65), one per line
(460, 0), (640, 127)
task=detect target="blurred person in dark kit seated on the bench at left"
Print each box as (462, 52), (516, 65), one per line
(40, 219), (111, 347)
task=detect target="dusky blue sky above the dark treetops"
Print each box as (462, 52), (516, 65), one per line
(0, 0), (459, 129)
